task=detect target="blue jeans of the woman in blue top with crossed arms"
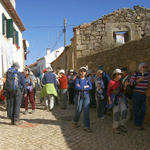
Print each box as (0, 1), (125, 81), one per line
(73, 93), (90, 128)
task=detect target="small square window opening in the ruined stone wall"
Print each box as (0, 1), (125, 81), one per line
(113, 31), (129, 44)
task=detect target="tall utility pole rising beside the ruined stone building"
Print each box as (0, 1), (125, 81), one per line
(63, 18), (67, 71)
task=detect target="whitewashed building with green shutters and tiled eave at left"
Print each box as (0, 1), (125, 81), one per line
(0, 0), (28, 78)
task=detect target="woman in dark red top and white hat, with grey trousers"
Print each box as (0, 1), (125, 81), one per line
(107, 69), (127, 134)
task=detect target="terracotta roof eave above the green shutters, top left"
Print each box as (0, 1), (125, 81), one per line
(2, 0), (26, 31)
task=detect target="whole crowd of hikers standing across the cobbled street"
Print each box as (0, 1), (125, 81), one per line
(0, 63), (150, 134)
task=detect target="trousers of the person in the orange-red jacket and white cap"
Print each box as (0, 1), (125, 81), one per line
(60, 89), (68, 109)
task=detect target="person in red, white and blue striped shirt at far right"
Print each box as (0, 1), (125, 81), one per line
(130, 63), (150, 130)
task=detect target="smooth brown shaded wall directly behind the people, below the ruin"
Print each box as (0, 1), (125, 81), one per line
(77, 36), (150, 74)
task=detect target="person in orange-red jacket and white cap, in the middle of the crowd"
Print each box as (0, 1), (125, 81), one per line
(59, 69), (68, 109)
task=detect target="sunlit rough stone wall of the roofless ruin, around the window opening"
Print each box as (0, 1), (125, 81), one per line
(72, 6), (150, 58)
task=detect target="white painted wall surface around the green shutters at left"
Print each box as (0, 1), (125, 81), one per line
(0, 2), (24, 77)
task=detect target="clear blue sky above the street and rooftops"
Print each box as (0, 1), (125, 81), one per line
(16, 0), (150, 64)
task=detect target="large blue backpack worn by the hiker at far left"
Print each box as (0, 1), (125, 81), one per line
(5, 68), (19, 93)
